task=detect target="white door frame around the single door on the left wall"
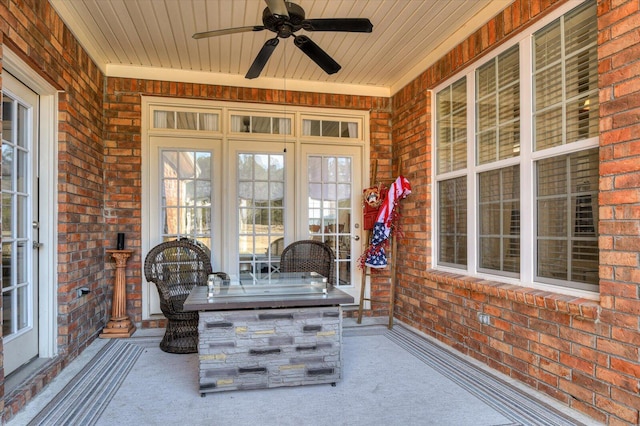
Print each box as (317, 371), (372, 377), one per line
(2, 49), (58, 358)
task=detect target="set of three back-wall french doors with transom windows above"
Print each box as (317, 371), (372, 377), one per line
(142, 98), (368, 318)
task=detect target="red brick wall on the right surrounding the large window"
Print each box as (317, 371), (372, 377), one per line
(393, 0), (640, 425)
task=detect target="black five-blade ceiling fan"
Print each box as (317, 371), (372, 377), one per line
(193, 0), (373, 78)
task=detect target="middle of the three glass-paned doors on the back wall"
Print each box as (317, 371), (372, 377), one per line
(227, 141), (295, 277)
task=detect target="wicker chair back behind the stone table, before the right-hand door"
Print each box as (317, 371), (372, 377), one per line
(280, 240), (336, 285)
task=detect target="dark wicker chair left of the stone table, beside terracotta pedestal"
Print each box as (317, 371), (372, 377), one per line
(144, 238), (219, 354)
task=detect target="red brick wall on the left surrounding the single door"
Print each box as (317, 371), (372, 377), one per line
(0, 0), (110, 420)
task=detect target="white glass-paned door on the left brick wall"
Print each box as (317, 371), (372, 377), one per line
(2, 73), (39, 375)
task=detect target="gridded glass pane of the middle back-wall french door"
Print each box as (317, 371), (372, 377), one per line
(236, 152), (285, 277)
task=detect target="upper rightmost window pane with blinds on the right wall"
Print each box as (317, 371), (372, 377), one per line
(533, 1), (598, 151)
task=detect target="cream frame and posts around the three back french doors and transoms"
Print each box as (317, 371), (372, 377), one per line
(141, 96), (370, 320)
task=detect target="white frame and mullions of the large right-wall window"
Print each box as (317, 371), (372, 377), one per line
(431, 0), (599, 299)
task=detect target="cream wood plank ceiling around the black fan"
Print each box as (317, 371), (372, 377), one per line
(49, 0), (513, 96)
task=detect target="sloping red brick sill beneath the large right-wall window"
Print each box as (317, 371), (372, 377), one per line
(425, 270), (600, 320)
